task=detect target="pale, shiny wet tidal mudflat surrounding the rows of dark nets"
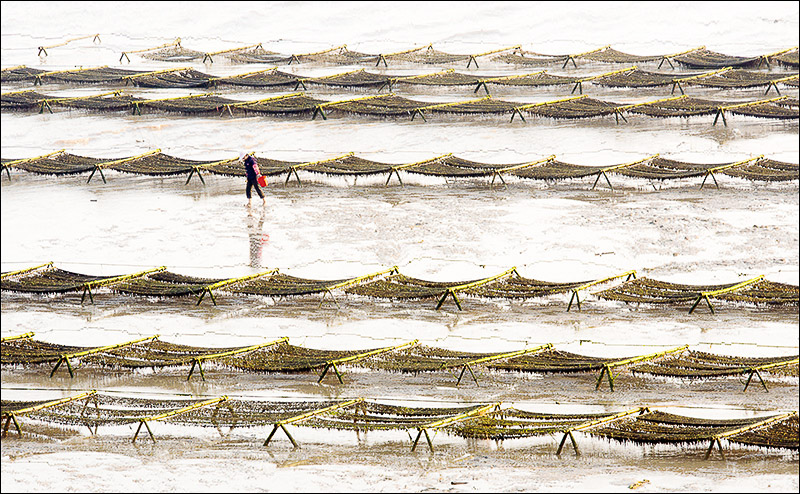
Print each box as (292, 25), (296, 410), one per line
(0, 2), (800, 492)
